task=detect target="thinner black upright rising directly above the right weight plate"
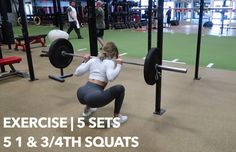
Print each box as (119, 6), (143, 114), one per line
(148, 0), (152, 50)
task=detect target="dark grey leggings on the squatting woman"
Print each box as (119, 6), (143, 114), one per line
(77, 82), (125, 114)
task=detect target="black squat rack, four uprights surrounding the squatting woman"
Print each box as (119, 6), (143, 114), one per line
(85, 0), (204, 115)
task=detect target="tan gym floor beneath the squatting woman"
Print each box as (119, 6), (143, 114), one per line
(0, 45), (236, 152)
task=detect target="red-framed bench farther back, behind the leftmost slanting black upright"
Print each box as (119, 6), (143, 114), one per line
(15, 34), (47, 52)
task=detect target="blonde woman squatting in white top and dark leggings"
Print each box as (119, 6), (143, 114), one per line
(74, 42), (128, 124)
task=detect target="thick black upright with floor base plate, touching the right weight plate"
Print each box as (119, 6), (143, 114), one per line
(154, 0), (165, 115)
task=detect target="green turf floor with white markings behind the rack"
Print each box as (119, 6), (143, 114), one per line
(14, 25), (236, 71)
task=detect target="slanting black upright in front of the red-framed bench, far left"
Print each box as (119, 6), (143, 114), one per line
(19, 0), (36, 81)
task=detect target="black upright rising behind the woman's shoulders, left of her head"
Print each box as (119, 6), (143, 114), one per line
(87, 0), (98, 56)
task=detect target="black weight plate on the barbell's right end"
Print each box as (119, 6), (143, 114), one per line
(143, 48), (160, 85)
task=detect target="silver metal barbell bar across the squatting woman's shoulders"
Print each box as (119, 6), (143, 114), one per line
(61, 51), (187, 73)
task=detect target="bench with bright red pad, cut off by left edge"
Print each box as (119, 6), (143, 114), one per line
(0, 56), (27, 79)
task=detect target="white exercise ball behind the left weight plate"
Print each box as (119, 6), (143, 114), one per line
(48, 29), (69, 42)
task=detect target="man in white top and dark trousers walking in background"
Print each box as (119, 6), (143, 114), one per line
(67, 1), (83, 39)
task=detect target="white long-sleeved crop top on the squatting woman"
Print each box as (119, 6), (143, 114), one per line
(74, 57), (121, 82)
